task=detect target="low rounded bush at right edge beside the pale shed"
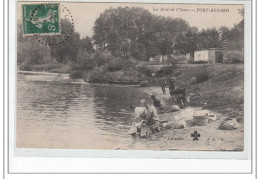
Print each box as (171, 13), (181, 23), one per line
(223, 50), (244, 64)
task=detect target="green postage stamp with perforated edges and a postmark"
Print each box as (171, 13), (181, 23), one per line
(22, 3), (61, 35)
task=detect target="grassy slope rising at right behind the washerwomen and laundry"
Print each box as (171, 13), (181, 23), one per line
(144, 64), (244, 119)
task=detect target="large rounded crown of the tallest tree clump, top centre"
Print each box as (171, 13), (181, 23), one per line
(93, 7), (189, 60)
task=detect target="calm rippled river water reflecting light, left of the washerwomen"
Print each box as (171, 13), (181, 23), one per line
(16, 73), (152, 149)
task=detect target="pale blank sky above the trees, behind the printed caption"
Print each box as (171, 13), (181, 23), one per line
(18, 2), (243, 38)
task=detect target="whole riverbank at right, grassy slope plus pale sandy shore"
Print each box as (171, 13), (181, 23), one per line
(137, 65), (244, 151)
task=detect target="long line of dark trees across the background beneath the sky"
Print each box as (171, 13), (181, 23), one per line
(18, 7), (244, 66)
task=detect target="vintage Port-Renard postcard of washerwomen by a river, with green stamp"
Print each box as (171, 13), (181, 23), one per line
(15, 1), (251, 157)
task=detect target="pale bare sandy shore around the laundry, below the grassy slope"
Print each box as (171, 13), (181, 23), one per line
(139, 87), (244, 151)
